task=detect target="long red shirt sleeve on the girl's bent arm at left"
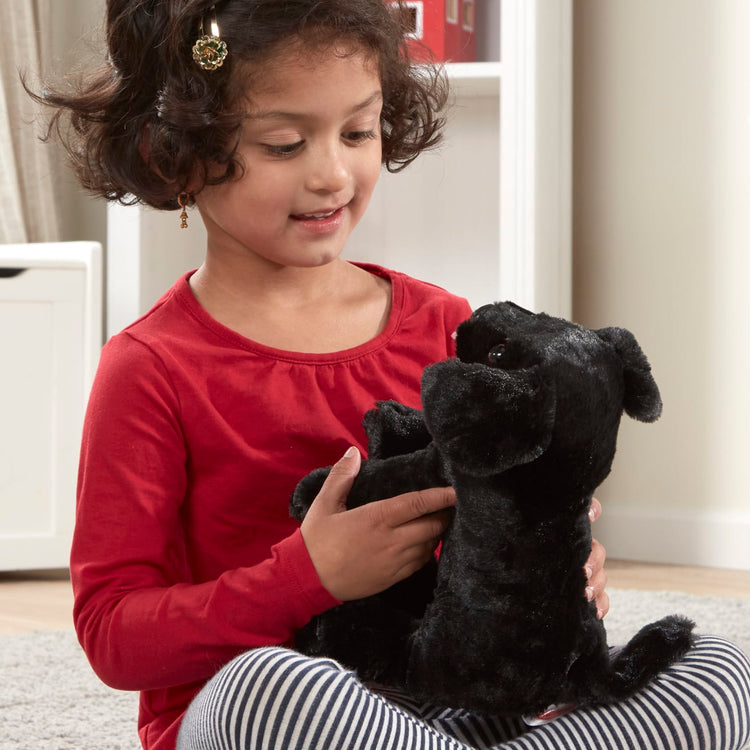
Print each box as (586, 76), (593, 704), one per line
(71, 334), (338, 690)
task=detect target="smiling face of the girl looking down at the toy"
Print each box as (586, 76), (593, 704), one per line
(196, 44), (382, 267)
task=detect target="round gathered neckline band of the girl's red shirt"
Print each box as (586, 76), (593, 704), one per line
(176, 261), (404, 364)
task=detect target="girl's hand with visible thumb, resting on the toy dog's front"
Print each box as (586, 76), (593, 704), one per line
(300, 448), (456, 601)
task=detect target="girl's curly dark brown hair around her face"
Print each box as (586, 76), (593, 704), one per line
(30, 0), (448, 209)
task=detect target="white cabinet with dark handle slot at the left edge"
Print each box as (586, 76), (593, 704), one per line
(0, 242), (102, 570)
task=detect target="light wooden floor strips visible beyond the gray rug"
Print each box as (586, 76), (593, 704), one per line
(0, 560), (750, 635)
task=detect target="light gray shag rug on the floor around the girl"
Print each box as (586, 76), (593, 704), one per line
(0, 590), (750, 750)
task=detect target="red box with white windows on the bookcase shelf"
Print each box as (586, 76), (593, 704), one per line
(389, 0), (477, 62)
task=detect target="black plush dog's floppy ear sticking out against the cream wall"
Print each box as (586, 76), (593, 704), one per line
(596, 328), (662, 422)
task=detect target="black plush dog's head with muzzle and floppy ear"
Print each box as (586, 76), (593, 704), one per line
(422, 302), (661, 483)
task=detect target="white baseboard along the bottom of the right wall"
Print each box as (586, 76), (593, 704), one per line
(594, 504), (750, 570)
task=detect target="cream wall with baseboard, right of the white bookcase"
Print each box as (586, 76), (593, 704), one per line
(573, 0), (750, 569)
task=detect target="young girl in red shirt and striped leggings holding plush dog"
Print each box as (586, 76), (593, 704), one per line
(45, 0), (750, 750)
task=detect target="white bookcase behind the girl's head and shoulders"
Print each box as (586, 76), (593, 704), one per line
(107, 0), (572, 334)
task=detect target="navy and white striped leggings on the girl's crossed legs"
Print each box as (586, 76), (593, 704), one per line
(177, 636), (750, 750)
